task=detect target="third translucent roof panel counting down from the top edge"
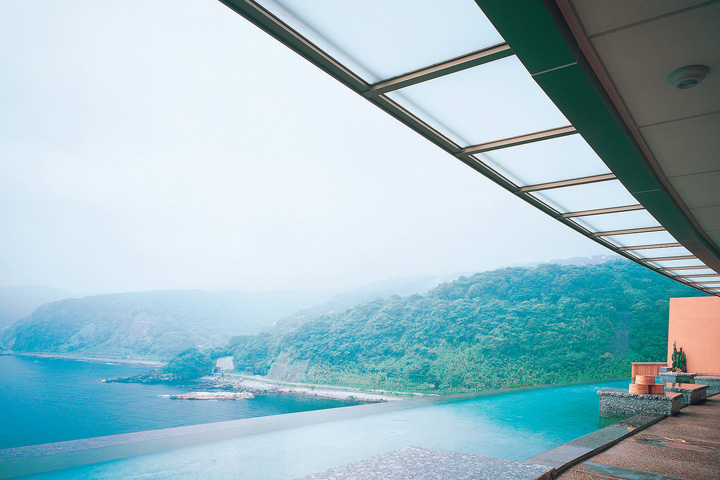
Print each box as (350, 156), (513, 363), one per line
(474, 135), (610, 187)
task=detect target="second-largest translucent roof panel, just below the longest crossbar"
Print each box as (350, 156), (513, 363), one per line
(387, 56), (569, 147)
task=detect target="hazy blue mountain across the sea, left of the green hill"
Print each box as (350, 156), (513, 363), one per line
(0, 290), (328, 359)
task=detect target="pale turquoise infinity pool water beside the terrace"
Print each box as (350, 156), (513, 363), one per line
(26, 380), (628, 480)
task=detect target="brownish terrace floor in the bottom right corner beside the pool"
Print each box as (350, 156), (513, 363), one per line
(558, 395), (720, 480)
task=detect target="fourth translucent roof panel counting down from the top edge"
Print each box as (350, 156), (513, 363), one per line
(531, 180), (637, 213)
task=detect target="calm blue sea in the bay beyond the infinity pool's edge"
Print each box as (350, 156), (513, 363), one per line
(0, 355), (360, 449)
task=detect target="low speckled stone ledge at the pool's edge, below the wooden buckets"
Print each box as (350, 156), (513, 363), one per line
(598, 388), (682, 417)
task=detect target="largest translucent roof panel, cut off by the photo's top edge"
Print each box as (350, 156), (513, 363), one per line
(259, 0), (504, 83)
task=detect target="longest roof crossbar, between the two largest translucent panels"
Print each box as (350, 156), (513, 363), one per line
(361, 43), (513, 98)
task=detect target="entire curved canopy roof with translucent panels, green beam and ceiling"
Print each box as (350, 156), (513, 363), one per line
(221, 0), (720, 295)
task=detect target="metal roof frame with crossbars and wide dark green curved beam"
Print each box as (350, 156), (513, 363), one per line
(220, 0), (720, 295)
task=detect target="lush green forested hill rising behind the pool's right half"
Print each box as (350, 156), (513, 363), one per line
(230, 260), (702, 393)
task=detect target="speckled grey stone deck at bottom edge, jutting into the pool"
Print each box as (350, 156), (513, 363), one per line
(302, 446), (549, 480)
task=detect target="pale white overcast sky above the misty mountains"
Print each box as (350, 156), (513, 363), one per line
(0, 0), (609, 294)
